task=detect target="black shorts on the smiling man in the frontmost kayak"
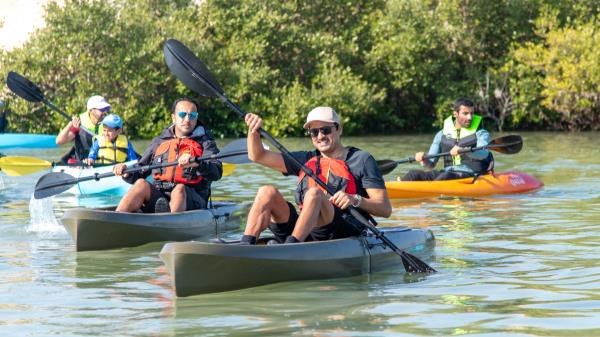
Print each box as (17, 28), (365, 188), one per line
(269, 202), (361, 242)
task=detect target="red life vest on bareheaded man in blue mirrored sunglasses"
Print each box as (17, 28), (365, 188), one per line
(152, 138), (203, 185)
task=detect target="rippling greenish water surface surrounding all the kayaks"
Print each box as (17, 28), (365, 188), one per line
(0, 133), (600, 337)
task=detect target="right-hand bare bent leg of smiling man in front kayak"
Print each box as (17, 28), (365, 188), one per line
(292, 187), (335, 241)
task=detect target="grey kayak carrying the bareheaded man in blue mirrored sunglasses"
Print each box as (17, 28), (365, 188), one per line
(61, 202), (246, 251)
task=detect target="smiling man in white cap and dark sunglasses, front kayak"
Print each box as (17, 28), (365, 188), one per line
(240, 107), (392, 244)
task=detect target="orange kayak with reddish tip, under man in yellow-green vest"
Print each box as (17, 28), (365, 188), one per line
(385, 172), (544, 199)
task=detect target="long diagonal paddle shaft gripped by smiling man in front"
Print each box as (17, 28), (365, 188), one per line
(191, 72), (426, 272)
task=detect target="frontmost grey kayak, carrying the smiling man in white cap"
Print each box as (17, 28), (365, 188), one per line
(160, 227), (435, 297)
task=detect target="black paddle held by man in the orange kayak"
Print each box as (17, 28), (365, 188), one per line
(377, 135), (523, 174)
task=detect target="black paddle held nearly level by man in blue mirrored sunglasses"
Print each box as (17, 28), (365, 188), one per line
(33, 139), (250, 199)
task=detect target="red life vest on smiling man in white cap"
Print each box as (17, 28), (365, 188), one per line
(295, 155), (357, 208)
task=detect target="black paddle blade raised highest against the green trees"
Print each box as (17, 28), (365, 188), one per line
(163, 39), (223, 97)
